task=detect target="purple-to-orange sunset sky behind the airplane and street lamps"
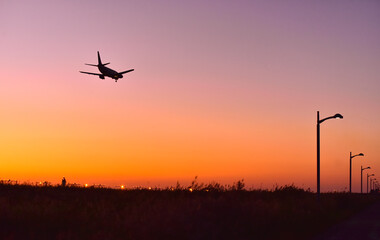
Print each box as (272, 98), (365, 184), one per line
(0, 0), (380, 192)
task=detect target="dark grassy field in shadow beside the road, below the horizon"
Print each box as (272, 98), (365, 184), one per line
(0, 184), (380, 239)
